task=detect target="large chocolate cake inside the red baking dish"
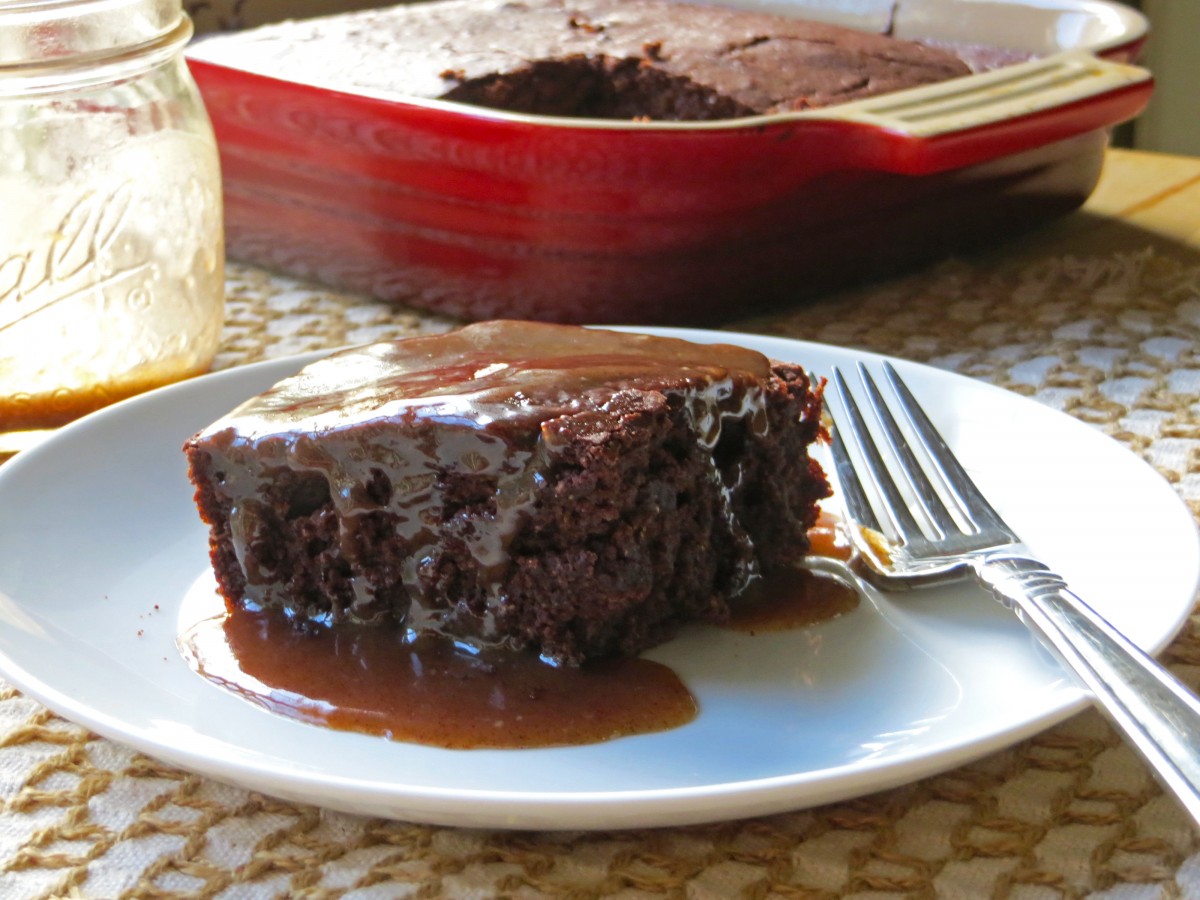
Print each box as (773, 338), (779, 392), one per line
(194, 0), (971, 120)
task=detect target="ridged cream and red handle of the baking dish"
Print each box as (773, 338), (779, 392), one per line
(829, 50), (1153, 174)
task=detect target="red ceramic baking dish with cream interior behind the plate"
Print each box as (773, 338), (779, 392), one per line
(190, 0), (1152, 324)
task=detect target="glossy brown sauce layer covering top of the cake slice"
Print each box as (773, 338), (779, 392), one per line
(204, 320), (770, 446)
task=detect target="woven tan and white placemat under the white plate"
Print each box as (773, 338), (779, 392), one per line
(0, 248), (1200, 900)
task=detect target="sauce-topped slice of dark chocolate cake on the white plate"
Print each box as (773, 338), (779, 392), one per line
(185, 322), (828, 662)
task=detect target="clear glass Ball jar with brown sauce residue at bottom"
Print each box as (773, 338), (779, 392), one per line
(0, 0), (224, 458)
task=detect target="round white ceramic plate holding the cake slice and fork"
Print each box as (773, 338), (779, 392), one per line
(0, 329), (1200, 829)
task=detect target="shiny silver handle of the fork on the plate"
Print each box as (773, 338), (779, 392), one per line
(976, 557), (1200, 823)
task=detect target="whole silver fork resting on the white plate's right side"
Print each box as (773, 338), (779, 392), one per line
(830, 364), (1200, 823)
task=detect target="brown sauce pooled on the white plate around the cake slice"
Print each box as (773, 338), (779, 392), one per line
(180, 516), (858, 749)
